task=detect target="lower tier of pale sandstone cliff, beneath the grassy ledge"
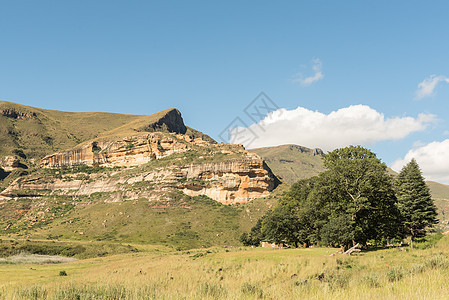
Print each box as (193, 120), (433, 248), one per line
(1, 159), (277, 204)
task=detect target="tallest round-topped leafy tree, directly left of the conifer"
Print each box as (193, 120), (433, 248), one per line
(320, 146), (400, 247)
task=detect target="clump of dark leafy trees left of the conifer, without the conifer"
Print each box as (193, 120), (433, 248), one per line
(250, 146), (400, 248)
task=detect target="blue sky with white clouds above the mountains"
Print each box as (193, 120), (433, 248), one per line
(0, 0), (449, 183)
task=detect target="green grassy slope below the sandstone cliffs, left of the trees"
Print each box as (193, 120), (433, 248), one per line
(0, 187), (276, 249)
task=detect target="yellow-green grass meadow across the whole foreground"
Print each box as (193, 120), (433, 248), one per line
(0, 237), (449, 299)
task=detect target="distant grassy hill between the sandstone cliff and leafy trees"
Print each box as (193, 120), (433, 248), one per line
(249, 145), (324, 184)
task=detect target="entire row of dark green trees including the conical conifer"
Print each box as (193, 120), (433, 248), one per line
(241, 146), (437, 248)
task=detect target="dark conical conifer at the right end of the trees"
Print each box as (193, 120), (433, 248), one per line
(396, 159), (438, 248)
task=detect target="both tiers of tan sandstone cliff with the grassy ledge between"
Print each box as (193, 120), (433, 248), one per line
(1, 132), (278, 204)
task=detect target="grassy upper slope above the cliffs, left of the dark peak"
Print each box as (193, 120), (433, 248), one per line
(0, 101), (213, 159)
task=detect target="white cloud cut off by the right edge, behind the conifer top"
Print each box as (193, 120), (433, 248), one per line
(391, 139), (449, 184)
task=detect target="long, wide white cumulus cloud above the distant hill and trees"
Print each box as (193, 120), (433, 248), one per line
(231, 105), (436, 151)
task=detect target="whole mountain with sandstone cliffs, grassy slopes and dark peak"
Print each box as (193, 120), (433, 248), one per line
(0, 102), (279, 249)
